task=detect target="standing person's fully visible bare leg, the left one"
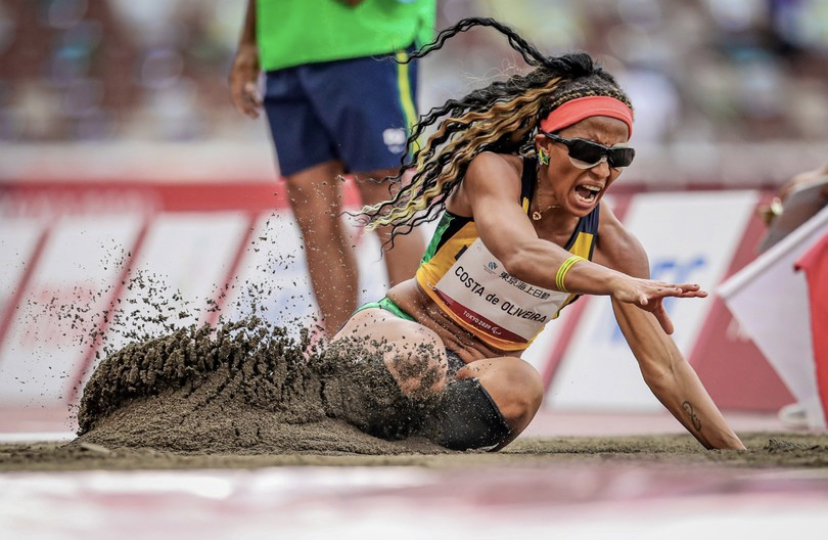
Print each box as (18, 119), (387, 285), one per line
(285, 161), (359, 336)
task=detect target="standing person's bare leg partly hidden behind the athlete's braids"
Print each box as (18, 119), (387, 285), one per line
(356, 170), (425, 287)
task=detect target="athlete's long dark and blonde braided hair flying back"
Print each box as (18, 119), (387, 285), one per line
(361, 17), (632, 240)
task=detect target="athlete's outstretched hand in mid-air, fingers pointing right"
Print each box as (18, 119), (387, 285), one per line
(612, 275), (707, 334)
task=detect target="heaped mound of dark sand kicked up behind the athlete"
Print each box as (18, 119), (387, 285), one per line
(76, 317), (446, 454)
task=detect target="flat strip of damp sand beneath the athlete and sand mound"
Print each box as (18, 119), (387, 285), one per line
(0, 430), (828, 472)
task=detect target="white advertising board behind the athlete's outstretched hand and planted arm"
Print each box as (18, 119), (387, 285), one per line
(547, 191), (758, 411)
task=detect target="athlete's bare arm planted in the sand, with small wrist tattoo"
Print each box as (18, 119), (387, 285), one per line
(595, 207), (745, 450)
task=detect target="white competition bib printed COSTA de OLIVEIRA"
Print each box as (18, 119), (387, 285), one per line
(434, 238), (570, 343)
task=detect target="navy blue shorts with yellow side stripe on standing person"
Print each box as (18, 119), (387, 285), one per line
(264, 51), (417, 176)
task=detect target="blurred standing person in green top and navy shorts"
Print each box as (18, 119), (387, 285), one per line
(229, 0), (436, 334)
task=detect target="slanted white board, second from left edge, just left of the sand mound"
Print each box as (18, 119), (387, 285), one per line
(0, 214), (144, 405)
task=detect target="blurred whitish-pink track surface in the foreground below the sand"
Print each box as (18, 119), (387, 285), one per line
(0, 466), (828, 540)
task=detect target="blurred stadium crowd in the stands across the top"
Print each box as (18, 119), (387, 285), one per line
(0, 0), (828, 185)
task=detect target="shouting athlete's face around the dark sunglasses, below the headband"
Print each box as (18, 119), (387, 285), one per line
(536, 116), (629, 216)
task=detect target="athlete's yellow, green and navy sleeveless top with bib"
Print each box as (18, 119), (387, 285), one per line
(416, 157), (600, 351)
